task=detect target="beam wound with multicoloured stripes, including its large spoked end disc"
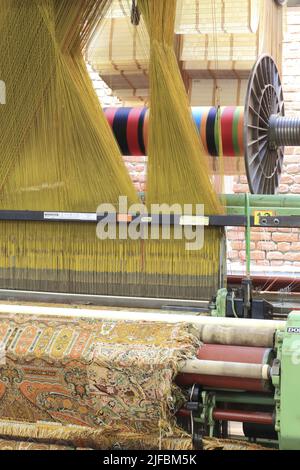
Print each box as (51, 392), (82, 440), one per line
(105, 54), (300, 194)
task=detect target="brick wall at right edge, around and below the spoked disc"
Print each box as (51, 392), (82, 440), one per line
(227, 7), (300, 275)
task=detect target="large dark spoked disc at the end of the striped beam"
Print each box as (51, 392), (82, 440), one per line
(244, 54), (284, 194)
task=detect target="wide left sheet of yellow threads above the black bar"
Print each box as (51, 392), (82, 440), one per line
(0, 0), (138, 212)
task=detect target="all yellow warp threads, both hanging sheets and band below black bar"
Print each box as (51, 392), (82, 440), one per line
(0, 0), (225, 298)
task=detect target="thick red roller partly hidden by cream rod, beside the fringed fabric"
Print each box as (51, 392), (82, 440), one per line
(177, 344), (272, 392)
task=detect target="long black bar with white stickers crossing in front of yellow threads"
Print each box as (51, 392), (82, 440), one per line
(0, 210), (300, 228)
